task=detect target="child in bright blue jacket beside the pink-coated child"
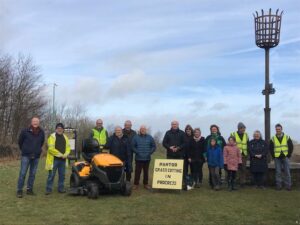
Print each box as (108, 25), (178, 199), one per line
(207, 137), (224, 191)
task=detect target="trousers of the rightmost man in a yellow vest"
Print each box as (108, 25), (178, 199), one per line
(275, 157), (292, 187)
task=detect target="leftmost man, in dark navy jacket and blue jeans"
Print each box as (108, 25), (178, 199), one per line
(17, 117), (45, 198)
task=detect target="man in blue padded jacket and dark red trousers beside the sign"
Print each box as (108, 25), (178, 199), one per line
(132, 125), (156, 190)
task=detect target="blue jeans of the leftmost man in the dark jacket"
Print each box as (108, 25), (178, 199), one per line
(17, 156), (39, 191)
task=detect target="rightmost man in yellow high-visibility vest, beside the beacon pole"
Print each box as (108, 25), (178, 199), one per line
(270, 124), (294, 191)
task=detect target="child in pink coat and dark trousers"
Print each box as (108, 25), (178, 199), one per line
(223, 137), (242, 191)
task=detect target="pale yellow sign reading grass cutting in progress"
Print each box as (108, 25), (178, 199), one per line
(152, 159), (183, 190)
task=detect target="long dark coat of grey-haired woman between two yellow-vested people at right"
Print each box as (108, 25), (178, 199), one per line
(248, 139), (268, 172)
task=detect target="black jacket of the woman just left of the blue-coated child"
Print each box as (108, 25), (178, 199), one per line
(187, 137), (206, 162)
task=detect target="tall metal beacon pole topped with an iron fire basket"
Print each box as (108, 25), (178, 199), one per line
(253, 9), (283, 145)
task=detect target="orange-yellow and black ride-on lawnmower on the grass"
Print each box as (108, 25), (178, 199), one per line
(70, 138), (132, 199)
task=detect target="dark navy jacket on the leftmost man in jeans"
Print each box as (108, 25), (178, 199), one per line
(18, 128), (45, 158)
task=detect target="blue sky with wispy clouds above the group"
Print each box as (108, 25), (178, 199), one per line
(0, 0), (300, 140)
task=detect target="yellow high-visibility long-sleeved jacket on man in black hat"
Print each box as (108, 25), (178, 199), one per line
(46, 133), (71, 170)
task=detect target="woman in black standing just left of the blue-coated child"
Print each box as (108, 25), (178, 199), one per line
(187, 128), (206, 188)
